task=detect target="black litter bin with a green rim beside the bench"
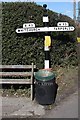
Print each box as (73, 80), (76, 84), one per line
(35, 70), (57, 105)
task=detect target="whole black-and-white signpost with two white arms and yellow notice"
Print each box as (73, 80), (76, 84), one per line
(16, 4), (75, 69)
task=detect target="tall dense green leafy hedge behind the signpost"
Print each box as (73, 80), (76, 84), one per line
(2, 2), (77, 68)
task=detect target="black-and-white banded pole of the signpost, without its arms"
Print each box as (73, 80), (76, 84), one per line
(43, 4), (51, 69)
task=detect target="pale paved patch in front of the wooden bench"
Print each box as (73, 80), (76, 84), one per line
(2, 97), (45, 118)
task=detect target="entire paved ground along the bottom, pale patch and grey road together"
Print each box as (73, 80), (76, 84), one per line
(0, 92), (78, 118)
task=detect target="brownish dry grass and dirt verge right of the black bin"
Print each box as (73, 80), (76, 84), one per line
(56, 67), (78, 100)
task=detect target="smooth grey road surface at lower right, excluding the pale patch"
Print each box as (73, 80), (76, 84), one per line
(43, 92), (78, 118)
